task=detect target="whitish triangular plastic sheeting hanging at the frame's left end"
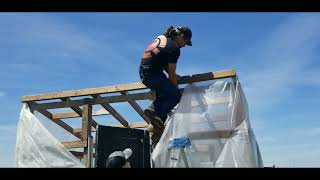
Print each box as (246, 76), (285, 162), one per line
(15, 103), (85, 168)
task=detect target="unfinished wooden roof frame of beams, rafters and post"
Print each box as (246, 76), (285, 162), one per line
(21, 69), (236, 167)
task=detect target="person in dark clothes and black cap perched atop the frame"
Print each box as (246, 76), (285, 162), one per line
(139, 26), (192, 141)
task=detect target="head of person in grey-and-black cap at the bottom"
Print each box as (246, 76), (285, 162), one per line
(106, 148), (132, 168)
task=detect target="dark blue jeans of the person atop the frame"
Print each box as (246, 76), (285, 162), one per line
(139, 68), (181, 123)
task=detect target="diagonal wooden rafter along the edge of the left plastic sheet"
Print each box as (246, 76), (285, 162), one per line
(28, 102), (81, 139)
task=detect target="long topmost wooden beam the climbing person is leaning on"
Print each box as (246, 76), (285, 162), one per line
(21, 69), (236, 102)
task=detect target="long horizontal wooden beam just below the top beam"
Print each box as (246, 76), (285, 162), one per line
(38, 92), (155, 109)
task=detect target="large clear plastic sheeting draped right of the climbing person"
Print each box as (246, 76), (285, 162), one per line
(152, 78), (263, 168)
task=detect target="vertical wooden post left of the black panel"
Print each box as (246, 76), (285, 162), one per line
(81, 104), (92, 168)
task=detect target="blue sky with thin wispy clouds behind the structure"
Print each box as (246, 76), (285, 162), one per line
(0, 12), (320, 167)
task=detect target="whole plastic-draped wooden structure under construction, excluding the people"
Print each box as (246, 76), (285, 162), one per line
(16, 69), (263, 168)
